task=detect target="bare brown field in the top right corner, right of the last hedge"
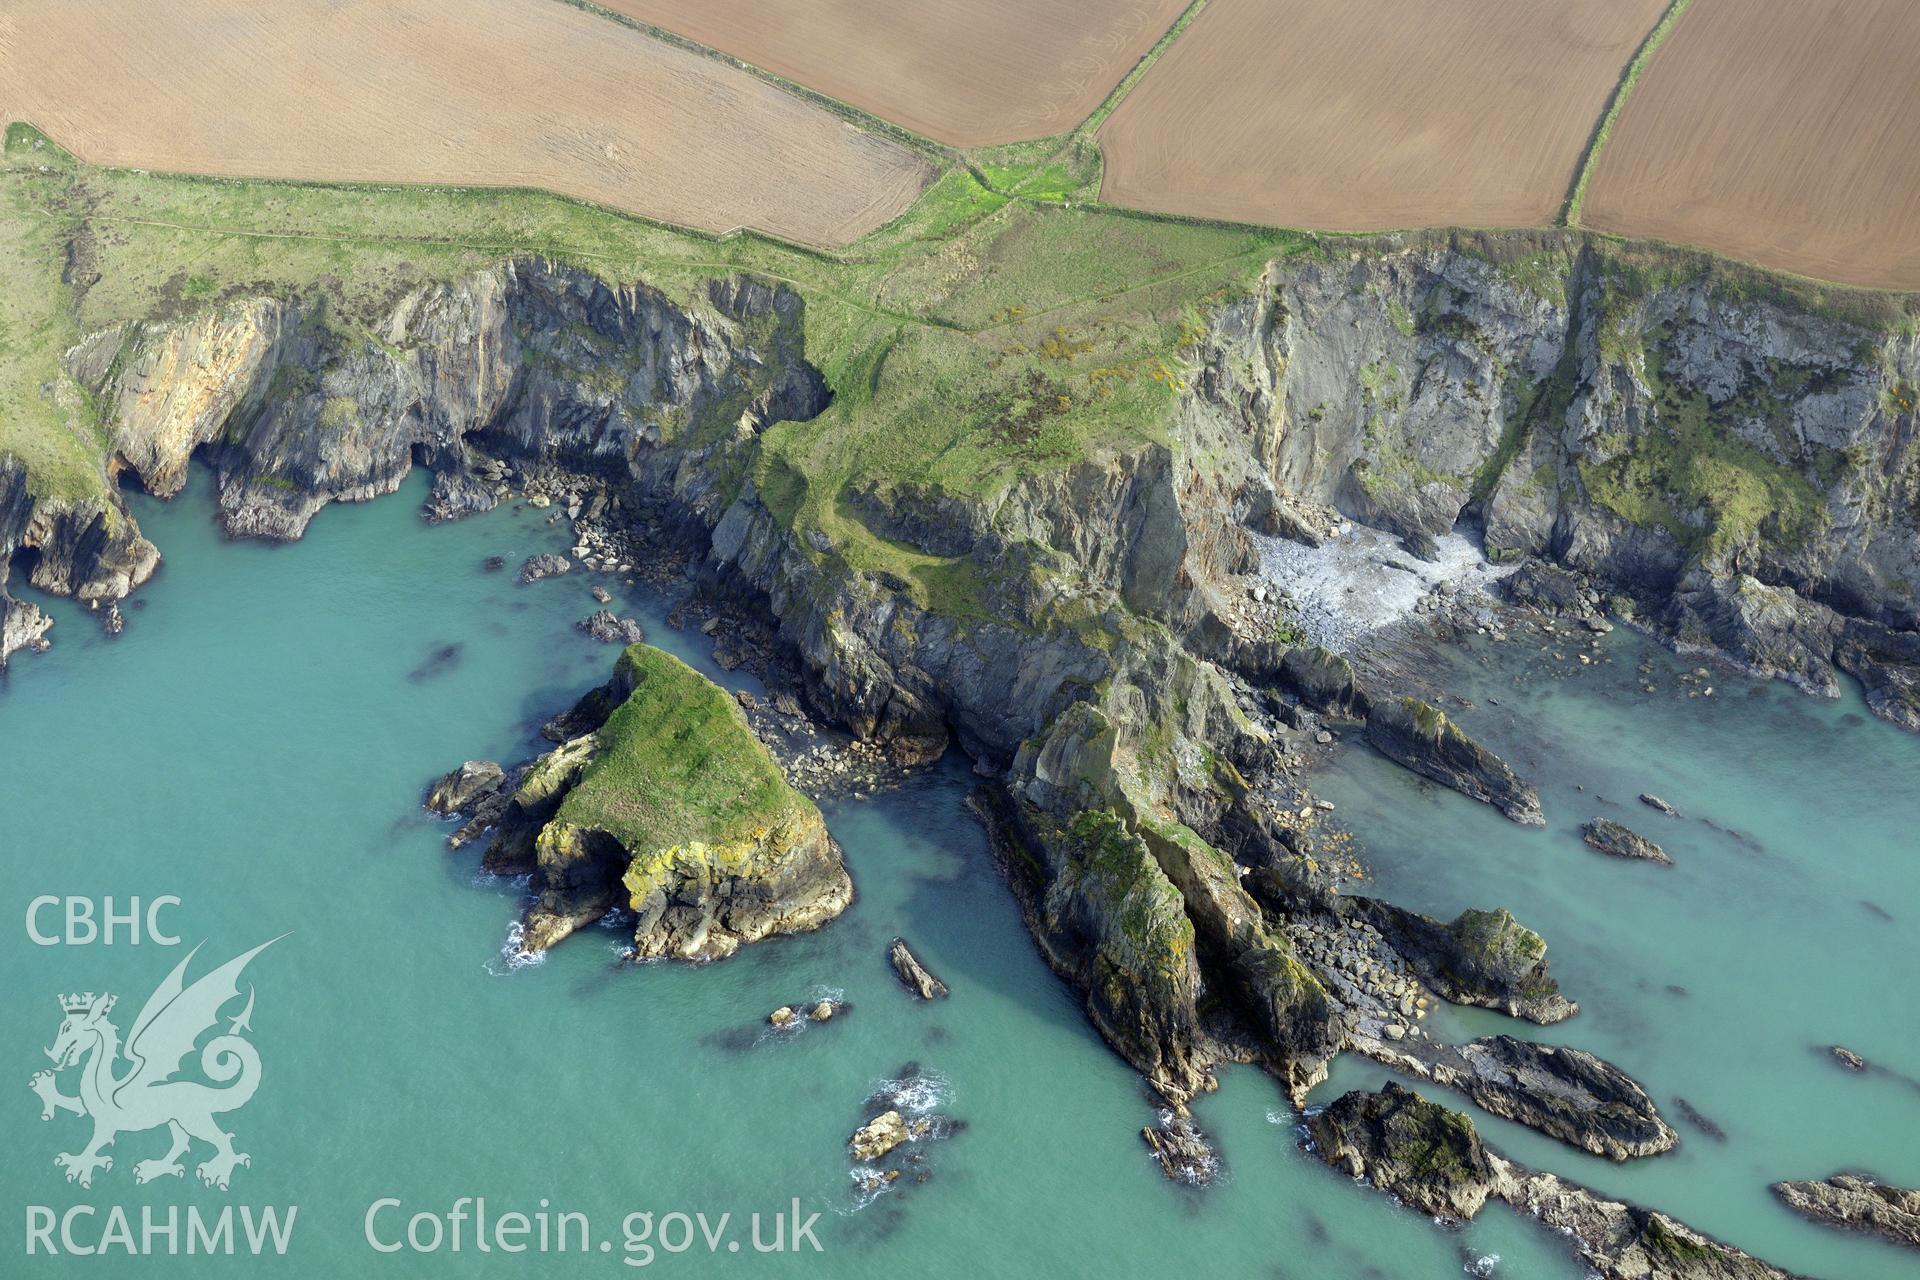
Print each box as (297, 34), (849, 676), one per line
(1582, 0), (1920, 290)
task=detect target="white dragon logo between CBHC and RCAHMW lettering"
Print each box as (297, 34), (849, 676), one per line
(33, 935), (286, 1192)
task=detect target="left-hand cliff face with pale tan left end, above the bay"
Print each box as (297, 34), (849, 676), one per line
(69, 261), (828, 537)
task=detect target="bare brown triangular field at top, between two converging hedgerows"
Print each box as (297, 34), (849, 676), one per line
(597, 0), (1187, 146)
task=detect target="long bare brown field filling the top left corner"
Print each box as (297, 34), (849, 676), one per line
(0, 0), (931, 246)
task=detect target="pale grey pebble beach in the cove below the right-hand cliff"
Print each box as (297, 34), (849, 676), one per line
(1254, 524), (1517, 652)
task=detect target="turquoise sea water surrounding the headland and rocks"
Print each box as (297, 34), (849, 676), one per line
(0, 478), (1920, 1280)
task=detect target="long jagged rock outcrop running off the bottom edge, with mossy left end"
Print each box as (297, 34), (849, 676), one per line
(1308, 1084), (1791, 1280)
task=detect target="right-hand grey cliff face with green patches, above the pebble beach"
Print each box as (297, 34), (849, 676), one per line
(1190, 240), (1920, 727)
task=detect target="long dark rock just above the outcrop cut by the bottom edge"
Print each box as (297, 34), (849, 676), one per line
(1363, 1036), (1680, 1161)
